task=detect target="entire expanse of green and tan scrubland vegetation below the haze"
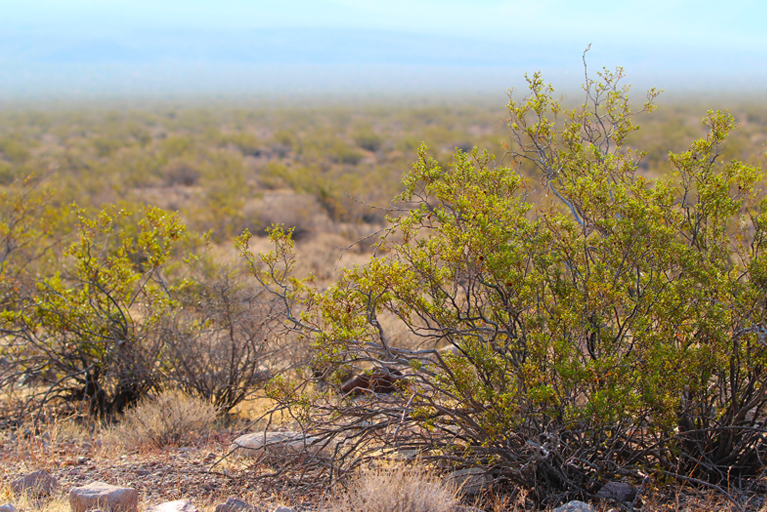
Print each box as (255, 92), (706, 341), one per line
(0, 66), (767, 510)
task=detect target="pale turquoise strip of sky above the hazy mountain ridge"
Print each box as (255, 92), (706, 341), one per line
(7, 0), (767, 48)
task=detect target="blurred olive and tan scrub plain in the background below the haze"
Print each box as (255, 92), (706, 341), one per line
(0, 98), (767, 252)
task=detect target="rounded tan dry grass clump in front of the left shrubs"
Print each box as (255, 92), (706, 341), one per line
(108, 391), (217, 448)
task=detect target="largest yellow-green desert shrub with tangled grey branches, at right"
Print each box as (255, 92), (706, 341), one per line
(240, 64), (767, 504)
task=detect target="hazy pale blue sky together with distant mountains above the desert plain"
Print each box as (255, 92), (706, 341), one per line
(0, 0), (767, 96)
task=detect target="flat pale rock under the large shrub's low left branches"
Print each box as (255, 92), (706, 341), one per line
(229, 432), (335, 462)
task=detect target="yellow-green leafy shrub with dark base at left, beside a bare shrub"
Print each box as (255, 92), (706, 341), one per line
(2, 207), (187, 416)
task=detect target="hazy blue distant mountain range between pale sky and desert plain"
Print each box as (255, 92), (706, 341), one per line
(0, 29), (767, 96)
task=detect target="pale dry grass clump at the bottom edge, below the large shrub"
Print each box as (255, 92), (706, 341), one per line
(326, 466), (459, 512)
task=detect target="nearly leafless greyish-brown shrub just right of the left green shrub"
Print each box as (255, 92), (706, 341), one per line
(162, 272), (290, 413)
